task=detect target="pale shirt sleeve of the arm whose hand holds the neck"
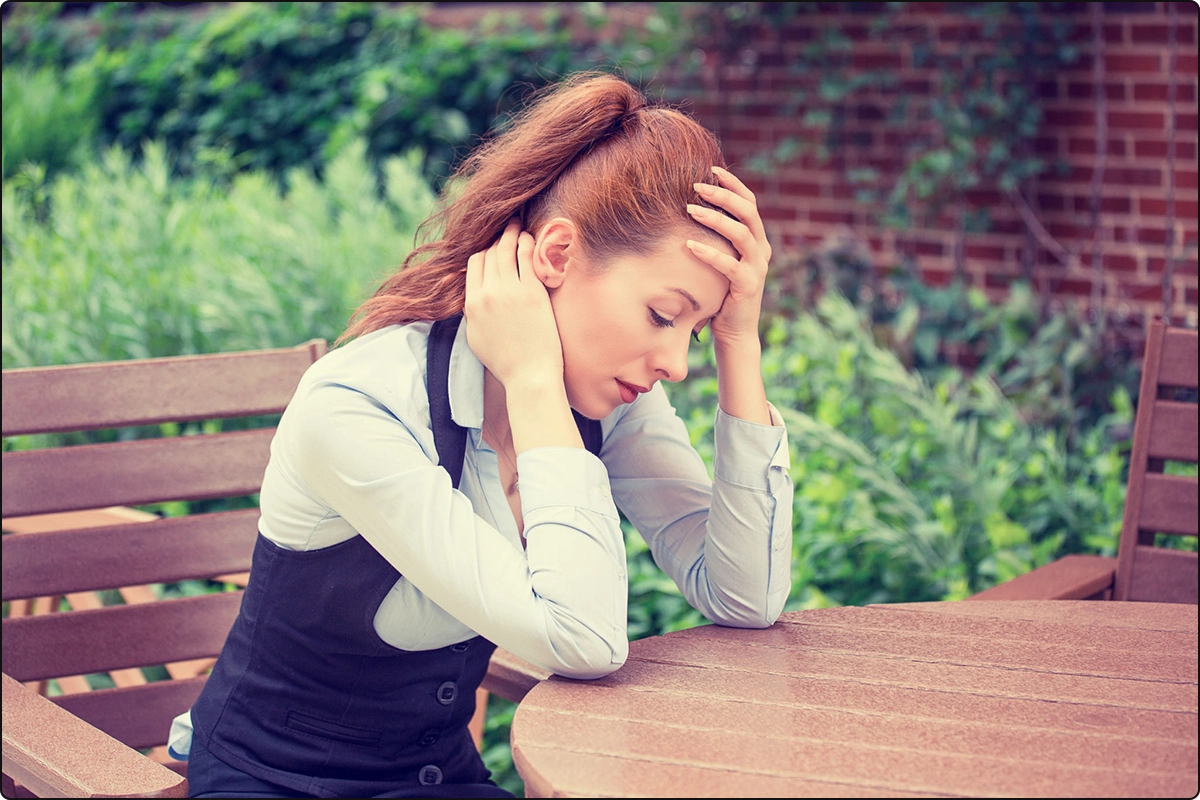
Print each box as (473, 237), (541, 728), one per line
(282, 384), (628, 678)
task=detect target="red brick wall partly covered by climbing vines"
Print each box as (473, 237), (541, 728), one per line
(685, 2), (1198, 326)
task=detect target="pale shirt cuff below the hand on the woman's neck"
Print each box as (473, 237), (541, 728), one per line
(517, 447), (619, 519)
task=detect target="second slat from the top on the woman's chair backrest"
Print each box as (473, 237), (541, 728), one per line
(2, 428), (275, 517)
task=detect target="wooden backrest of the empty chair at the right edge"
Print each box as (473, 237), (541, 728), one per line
(1112, 320), (1198, 603)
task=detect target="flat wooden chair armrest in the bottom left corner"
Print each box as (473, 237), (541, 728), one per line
(4, 675), (187, 798)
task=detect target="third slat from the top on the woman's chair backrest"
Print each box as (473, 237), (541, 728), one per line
(0, 509), (259, 601)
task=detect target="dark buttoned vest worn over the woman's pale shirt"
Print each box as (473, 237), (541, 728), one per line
(192, 315), (600, 796)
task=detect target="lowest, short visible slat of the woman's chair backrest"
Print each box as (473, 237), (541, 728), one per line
(52, 675), (208, 748)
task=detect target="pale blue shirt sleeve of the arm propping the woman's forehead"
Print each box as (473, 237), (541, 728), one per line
(602, 386), (792, 627)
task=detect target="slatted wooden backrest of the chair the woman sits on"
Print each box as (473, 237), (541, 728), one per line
(2, 339), (326, 767)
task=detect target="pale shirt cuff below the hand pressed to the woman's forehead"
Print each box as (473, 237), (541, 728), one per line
(713, 403), (792, 492)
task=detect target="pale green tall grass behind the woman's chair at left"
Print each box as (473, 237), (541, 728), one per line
(2, 142), (433, 369)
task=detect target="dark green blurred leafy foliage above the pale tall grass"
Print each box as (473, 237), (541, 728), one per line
(4, 2), (686, 186)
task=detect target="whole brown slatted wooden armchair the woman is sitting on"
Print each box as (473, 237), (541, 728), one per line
(2, 339), (548, 798)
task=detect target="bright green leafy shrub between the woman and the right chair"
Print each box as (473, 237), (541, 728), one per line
(662, 293), (1130, 609)
